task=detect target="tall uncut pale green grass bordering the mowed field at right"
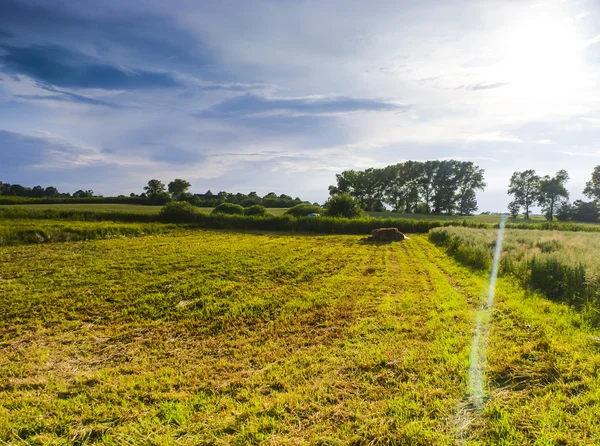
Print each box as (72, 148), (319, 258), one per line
(429, 228), (600, 325)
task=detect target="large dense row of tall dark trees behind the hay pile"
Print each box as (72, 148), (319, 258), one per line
(329, 160), (486, 215)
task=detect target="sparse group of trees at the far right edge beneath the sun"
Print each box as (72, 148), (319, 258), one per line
(508, 166), (600, 222)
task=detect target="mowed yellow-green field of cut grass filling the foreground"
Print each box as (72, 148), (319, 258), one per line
(0, 231), (600, 445)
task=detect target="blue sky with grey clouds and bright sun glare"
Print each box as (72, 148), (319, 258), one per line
(0, 0), (600, 211)
